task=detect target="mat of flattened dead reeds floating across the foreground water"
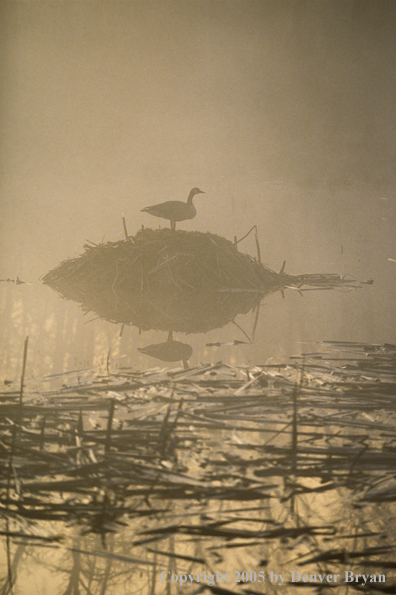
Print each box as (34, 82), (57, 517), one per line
(0, 342), (396, 595)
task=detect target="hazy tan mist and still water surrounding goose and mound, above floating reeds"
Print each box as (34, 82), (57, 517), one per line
(0, 0), (396, 372)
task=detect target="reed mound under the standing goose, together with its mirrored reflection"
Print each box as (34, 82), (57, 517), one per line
(43, 229), (285, 333)
